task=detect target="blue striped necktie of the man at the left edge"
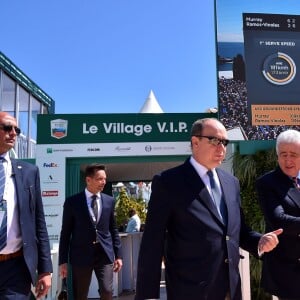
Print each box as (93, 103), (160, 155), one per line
(0, 157), (7, 250)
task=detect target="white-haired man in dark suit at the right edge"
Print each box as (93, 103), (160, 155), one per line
(256, 129), (300, 300)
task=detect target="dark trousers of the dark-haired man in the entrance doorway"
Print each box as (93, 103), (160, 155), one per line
(72, 245), (113, 300)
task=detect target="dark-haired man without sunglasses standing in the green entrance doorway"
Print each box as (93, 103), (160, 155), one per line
(59, 163), (122, 300)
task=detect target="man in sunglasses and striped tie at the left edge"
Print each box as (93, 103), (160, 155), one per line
(0, 112), (52, 300)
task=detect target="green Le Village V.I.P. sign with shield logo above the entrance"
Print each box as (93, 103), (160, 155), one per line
(37, 113), (217, 144)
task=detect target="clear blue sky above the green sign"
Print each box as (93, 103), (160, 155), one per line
(0, 0), (217, 113)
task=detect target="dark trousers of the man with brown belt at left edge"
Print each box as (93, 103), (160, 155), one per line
(0, 256), (31, 300)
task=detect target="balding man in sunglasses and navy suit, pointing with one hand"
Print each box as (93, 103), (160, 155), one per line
(135, 119), (281, 300)
